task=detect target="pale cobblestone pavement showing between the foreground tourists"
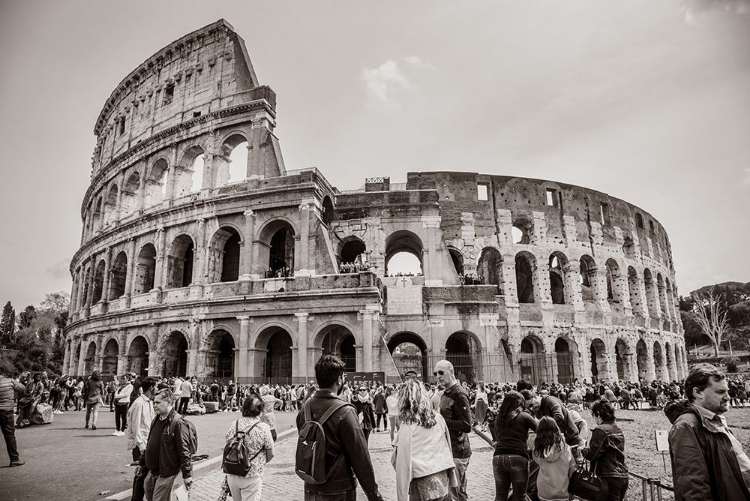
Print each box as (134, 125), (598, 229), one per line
(190, 426), (495, 501)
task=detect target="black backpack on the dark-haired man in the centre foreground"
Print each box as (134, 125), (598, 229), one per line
(294, 399), (354, 485)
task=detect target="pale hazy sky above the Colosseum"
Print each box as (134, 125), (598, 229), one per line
(0, 0), (750, 311)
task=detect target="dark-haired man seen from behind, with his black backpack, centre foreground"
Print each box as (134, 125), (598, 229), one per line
(295, 355), (383, 501)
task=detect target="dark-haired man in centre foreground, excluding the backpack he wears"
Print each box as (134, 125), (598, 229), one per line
(297, 355), (383, 501)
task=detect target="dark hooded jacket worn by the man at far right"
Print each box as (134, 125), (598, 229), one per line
(664, 400), (750, 501)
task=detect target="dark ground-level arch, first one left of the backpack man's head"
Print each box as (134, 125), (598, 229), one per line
(255, 324), (295, 384)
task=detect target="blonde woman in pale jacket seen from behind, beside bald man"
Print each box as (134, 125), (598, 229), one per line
(391, 379), (456, 501)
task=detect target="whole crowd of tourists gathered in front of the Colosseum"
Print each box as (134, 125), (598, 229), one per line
(0, 355), (750, 501)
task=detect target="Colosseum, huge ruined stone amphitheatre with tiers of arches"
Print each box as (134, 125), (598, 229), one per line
(65, 20), (687, 383)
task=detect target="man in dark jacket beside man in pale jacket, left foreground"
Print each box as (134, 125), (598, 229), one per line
(136, 389), (193, 501)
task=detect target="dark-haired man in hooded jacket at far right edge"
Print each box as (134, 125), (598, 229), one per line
(664, 364), (750, 501)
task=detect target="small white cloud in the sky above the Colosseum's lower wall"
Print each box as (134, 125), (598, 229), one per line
(361, 56), (435, 113)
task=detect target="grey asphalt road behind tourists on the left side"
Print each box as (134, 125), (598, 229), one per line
(0, 409), (296, 501)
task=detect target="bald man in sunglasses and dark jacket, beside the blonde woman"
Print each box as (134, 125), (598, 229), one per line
(434, 360), (474, 501)
